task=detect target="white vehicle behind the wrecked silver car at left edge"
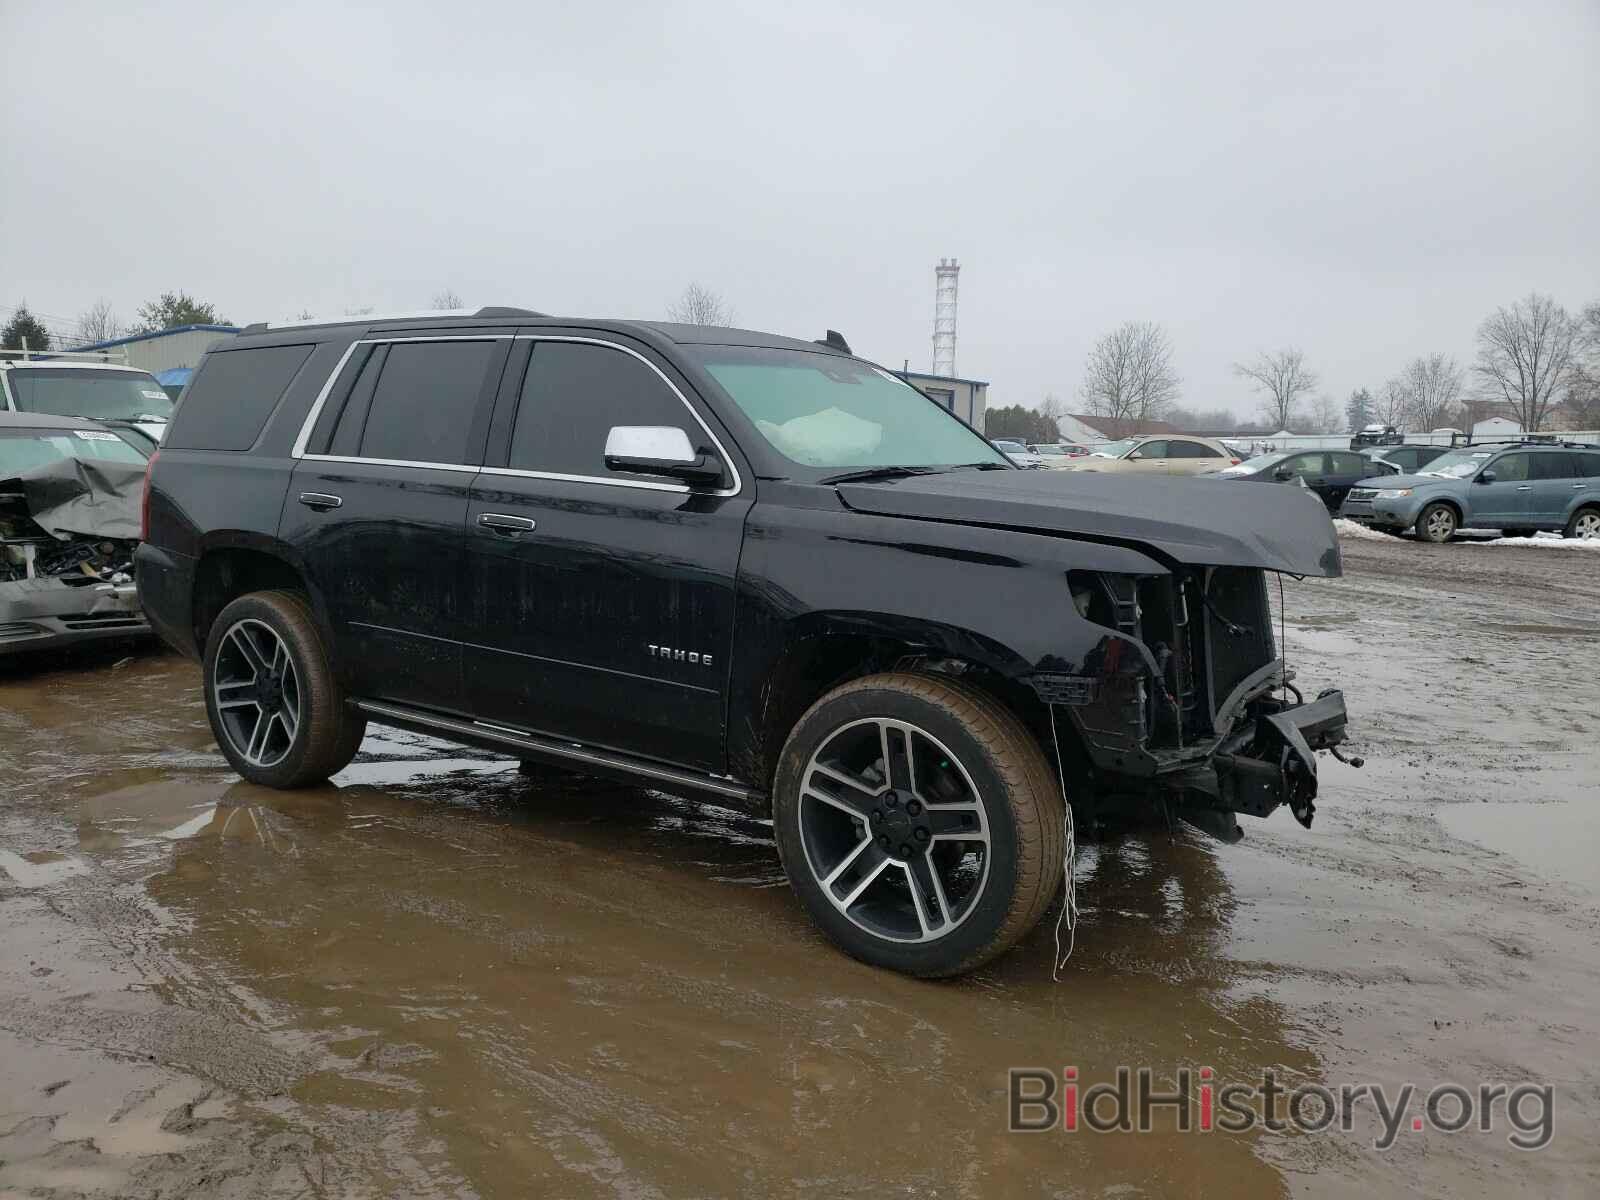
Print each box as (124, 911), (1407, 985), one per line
(0, 357), (173, 446)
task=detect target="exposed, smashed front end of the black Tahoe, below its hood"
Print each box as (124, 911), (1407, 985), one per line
(1034, 566), (1346, 842)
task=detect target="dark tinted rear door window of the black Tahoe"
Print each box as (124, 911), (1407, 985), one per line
(360, 341), (499, 462)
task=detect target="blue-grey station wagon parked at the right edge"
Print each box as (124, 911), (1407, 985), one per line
(1341, 442), (1600, 542)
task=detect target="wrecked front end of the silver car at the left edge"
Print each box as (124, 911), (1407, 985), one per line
(0, 458), (149, 654)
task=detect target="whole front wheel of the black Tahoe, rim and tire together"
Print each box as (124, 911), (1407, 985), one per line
(773, 674), (1066, 978)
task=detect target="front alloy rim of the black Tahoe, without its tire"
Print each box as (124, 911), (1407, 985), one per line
(798, 718), (990, 942)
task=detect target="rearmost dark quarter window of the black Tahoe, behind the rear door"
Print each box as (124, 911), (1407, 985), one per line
(163, 346), (315, 450)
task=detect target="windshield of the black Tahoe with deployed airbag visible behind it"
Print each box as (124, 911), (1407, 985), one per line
(685, 346), (1010, 467)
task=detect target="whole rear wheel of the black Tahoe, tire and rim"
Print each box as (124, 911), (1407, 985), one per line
(203, 592), (366, 789)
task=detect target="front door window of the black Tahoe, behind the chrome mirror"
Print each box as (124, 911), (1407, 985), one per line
(509, 341), (706, 480)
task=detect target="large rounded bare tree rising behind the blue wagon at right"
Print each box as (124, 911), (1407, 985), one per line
(1472, 291), (1582, 434)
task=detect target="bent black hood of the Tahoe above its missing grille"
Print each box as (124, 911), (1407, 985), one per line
(837, 470), (1344, 578)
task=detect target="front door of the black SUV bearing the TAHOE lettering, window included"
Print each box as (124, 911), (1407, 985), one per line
(464, 338), (750, 771)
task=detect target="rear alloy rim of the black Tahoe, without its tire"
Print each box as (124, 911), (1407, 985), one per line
(211, 619), (301, 766)
